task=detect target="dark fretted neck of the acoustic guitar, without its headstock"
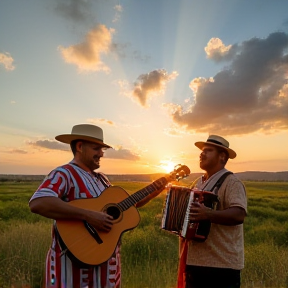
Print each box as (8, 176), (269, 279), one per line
(117, 177), (169, 211)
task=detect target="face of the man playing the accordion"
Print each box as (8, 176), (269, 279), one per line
(199, 144), (220, 171)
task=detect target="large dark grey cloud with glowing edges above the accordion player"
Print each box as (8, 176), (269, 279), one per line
(170, 32), (288, 135)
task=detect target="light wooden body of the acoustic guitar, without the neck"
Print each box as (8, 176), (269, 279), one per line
(56, 186), (140, 265)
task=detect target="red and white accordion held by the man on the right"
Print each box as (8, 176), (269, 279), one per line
(161, 185), (219, 242)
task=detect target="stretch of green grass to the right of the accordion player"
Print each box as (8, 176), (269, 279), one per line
(242, 182), (288, 288)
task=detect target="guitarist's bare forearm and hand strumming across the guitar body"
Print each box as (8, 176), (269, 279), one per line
(29, 196), (113, 232)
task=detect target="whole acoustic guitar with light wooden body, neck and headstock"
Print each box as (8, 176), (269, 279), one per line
(56, 164), (190, 265)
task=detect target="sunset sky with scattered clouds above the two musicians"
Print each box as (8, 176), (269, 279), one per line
(0, 0), (288, 175)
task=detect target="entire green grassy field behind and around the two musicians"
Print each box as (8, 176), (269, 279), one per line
(0, 182), (288, 288)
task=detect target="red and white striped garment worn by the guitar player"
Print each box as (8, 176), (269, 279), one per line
(30, 162), (121, 288)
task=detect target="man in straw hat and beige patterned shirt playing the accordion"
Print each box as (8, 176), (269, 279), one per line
(178, 135), (247, 288)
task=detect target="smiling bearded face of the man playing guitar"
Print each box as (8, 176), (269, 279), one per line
(81, 141), (105, 171)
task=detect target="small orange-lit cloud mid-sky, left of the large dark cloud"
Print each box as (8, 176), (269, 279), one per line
(132, 69), (178, 106)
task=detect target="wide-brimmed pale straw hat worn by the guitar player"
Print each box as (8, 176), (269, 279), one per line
(55, 124), (111, 148)
